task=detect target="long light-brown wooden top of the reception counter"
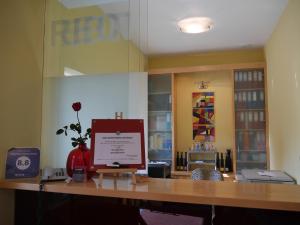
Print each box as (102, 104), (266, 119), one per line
(0, 177), (300, 212)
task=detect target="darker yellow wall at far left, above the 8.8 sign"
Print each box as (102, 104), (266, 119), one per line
(0, 0), (44, 225)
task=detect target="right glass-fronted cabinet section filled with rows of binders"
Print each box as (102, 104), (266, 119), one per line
(234, 68), (268, 172)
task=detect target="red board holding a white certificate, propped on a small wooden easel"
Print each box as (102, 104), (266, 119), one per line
(91, 119), (145, 169)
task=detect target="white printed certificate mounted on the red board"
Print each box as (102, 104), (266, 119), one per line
(94, 133), (142, 165)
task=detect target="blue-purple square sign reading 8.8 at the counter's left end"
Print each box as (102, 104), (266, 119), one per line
(5, 148), (40, 179)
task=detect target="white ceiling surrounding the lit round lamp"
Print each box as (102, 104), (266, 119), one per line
(59, 0), (288, 55)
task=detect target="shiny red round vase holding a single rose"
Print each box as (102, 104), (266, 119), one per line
(67, 144), (90, 177)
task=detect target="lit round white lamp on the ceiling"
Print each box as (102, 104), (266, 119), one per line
(177, 17), (213, 34)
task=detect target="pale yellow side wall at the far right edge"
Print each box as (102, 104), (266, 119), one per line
(265, 0), (300, 182)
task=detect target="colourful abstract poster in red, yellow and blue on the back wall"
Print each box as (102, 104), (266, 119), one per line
(192, 92), (215, 142)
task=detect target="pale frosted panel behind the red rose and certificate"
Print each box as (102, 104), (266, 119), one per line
(41, 73), (147, 170)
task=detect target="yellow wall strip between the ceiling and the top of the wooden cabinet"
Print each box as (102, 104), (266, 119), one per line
(148, 49), (265, 69)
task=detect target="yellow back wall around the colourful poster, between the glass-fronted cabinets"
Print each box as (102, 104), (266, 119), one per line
(175, 71), (234, 152)
